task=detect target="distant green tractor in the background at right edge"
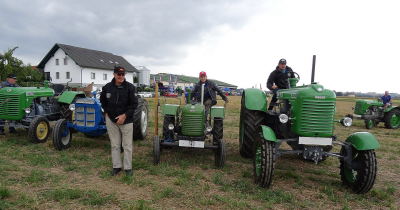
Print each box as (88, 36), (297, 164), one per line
(348, 99), (400, 129)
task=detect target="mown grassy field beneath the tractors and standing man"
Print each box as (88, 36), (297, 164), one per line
(0, 97), (400, 209)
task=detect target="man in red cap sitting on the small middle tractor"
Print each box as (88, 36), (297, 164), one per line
(192, 71), (228, 116)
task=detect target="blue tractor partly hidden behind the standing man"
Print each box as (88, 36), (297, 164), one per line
(53, 94), (148, 150)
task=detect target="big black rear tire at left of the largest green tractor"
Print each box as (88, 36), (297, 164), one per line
(239, 94), (265, 158)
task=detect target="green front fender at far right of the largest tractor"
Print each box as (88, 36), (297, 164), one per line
(346, 132), (380, 150)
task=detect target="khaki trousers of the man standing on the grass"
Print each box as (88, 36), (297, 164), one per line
(106, 116), (133, 170)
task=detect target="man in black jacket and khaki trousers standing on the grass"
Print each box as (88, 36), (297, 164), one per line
(100, 66), (138, 176)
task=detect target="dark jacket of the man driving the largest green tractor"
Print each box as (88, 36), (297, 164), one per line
(267, 66), (294, 90)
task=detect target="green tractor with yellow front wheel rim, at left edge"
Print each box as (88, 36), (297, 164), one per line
(0, 83), (84, 143)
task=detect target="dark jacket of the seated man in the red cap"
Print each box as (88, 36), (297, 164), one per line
(191, 80), (227, 105)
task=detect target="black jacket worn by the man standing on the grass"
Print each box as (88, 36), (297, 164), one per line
(100, 79), (138, 124)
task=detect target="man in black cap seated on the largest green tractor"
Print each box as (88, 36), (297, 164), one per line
(267, 58), (294, 110)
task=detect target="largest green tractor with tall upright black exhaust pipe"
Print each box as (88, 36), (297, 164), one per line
(239, 56), (379, 193)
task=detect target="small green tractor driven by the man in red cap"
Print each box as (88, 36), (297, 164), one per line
(153, 82), (225, 168)
